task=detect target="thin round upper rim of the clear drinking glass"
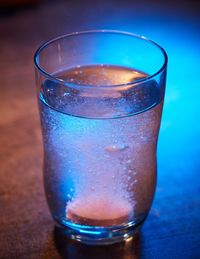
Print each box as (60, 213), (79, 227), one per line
(34, 29), (168, 89)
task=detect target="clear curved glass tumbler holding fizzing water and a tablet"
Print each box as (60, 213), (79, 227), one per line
(34, 30), (167, 244)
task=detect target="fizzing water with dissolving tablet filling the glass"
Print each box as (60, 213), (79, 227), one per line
(39, 65), (163, 231)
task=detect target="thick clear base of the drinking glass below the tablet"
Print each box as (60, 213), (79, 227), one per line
(55, 219), (145, 245)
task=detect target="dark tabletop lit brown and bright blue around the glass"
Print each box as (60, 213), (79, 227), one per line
(0, 0), (200, 259)
